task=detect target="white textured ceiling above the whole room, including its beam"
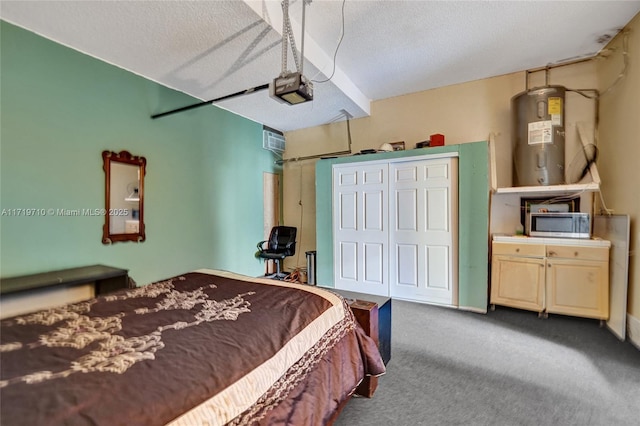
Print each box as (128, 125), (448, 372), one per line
(0, 0), (640, 131)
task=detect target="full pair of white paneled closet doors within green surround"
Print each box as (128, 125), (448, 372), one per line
(333, 157), (458, 305)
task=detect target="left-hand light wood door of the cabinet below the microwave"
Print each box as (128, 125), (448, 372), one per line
(491, 255), (545, 312)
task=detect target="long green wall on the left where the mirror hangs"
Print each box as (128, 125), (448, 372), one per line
(0, 22), (281, 285)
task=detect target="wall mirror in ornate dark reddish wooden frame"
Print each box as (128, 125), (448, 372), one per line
(102, 151), (147, 244)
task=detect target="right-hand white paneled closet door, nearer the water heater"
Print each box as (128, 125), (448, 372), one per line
(389, 158), (458, 305)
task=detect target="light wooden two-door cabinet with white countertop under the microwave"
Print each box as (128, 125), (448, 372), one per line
(490, 237), (610, 320)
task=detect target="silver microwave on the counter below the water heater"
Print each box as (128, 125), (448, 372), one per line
(529, 212), (591, 238)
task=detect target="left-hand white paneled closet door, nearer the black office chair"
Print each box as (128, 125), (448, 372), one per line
(333, 163), (389, 296)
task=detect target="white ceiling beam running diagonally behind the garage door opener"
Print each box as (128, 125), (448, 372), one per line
(243, 0), (371, 115)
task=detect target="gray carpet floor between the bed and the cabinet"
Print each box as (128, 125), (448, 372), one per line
(336, 300), (640, 426)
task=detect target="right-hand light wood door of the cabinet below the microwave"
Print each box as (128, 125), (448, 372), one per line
(546, 259), (609, 319)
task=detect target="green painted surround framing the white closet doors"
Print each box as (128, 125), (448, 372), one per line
(316, 142), (489, 312)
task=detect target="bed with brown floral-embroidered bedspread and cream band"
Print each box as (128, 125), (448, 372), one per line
(0, 270), (384, 426)
